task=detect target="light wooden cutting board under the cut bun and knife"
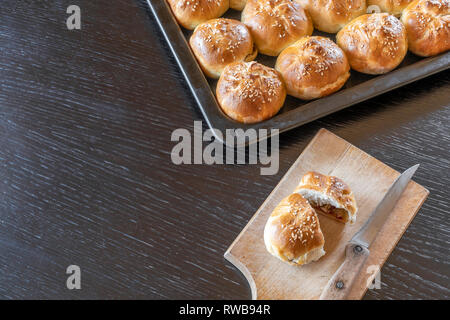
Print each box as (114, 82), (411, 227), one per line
(225, 129), (429, 299)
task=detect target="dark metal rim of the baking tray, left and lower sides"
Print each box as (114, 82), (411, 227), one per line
(147, 0), (450, 147)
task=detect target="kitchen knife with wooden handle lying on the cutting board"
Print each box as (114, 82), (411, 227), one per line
(319, 164), (419, 300)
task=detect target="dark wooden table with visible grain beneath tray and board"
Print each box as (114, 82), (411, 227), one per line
(0, 0), (450, 299)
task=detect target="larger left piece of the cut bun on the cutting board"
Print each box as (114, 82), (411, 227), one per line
(264, 193), (325, 265)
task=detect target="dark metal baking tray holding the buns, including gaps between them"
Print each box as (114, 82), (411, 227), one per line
(147, 0), (450, 144)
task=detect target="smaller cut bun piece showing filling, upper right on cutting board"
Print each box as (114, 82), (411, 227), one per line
(294, 172), (358, 224)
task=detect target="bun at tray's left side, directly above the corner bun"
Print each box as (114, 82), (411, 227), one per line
(189, 18), (258, 79)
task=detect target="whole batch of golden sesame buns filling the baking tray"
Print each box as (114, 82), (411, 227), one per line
(166, 0), (450, 123)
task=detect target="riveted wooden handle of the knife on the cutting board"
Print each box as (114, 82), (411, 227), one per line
(319, 243), (369, 300)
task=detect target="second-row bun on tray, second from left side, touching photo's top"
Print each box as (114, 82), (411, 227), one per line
(241, 0), (313, 56)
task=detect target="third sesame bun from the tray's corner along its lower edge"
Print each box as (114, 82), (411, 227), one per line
(336, 13), (408, 74)
